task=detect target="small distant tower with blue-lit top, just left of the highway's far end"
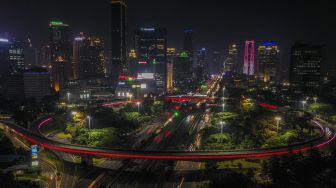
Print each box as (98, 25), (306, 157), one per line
(195, 48), (208, 82)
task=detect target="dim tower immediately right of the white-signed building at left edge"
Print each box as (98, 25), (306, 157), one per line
(9, 39), (25, 73)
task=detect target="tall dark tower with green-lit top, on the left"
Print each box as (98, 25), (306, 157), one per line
(49, 21), (73, 92)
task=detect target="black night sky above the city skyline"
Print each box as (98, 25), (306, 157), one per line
(0, 0), (336, 70)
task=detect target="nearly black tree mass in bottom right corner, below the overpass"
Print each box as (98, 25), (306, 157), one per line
(262, 150), (336, 187)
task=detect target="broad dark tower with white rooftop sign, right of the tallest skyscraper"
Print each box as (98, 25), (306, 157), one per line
(135, 28), (167, 94)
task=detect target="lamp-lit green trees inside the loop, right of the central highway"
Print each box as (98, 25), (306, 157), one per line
(203, 110), (318, 150)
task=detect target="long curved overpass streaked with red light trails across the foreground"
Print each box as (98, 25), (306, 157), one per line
(0, 118), (336, 161)
